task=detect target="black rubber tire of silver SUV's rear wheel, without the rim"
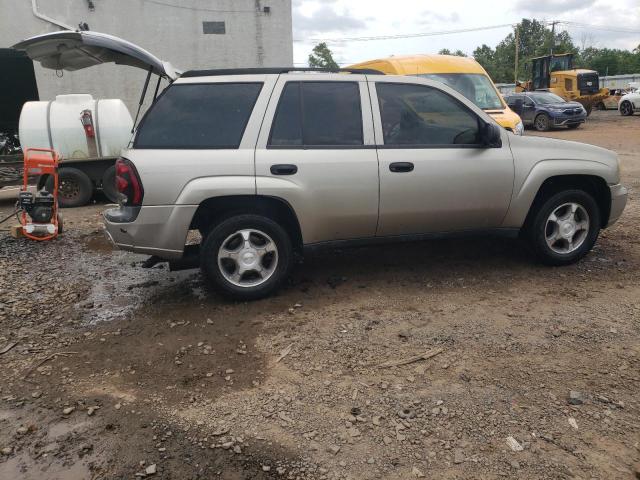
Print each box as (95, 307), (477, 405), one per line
(200, 214), (293, 300)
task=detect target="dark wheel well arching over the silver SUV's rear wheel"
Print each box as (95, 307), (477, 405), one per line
(190, 195), (302, 252)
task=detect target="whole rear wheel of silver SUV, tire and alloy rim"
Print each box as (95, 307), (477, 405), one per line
(200, 215), (293, 300)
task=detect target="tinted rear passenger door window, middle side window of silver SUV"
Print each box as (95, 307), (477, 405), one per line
(269, 82), (364, 147)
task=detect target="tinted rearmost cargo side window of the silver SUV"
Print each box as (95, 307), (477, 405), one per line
(134, 83), (262, 149)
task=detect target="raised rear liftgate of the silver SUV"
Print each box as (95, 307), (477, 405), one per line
(13, 31), (179, 81)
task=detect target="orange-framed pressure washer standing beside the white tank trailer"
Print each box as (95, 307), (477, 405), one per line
(16, 148), (62, 241)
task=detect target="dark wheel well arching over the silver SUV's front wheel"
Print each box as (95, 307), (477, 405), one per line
(525, 175), (611, 228)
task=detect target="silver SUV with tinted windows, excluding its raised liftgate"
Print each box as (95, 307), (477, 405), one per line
(15, 31), (627, 299)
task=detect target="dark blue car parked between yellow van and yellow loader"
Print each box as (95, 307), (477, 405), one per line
(505, 92), (587, 132)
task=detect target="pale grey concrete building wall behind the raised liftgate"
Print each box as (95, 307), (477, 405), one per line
(0, 0), (293, 115)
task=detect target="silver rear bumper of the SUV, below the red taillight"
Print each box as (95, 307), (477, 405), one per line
(103, 205), (198, 260)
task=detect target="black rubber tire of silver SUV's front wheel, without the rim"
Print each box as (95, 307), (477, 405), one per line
(525, 190), (602, 266)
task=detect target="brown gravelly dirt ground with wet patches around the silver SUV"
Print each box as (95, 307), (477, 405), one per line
(0, 112), (640, 480)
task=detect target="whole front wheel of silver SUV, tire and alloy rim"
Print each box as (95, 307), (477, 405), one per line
(526, 190), (601, 265)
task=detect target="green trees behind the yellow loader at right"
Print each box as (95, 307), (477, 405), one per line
(473, 18), (640, 83)
